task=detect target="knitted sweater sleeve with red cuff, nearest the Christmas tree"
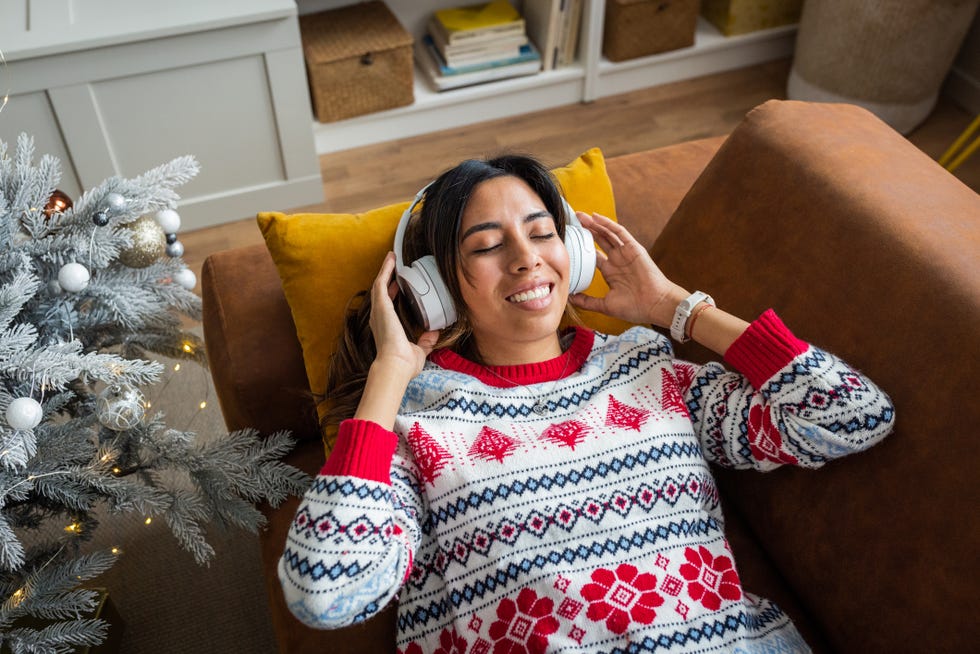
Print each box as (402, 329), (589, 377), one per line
(279, 420), (422, 629)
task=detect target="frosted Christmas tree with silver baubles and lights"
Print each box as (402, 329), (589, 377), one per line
(0, 135), (306, 652)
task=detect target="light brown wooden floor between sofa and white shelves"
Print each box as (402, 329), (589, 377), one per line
(181, 60), (980, 286)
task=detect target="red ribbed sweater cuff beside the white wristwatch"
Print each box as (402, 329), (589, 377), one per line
(725, 309), (810, 388)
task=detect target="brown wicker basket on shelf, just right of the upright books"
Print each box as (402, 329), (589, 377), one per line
(602, 0), (699, 61)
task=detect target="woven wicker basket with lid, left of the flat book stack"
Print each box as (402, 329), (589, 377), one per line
(299, 2), (415, 123)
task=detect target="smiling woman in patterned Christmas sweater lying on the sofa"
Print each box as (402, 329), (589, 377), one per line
(280, 156), (893, 654)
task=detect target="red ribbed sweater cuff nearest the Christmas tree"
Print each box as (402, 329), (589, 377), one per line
(320, 420), (398, 485)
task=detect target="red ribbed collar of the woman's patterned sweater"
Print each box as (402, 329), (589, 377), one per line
(429, 327), (595, 388)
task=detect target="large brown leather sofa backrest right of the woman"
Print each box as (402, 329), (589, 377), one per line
(652, 101), (980, 652)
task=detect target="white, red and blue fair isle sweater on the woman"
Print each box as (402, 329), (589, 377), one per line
(279, 311), (893, 654)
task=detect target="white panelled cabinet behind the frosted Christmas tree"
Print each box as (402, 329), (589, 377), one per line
(0, 0), (323, 229)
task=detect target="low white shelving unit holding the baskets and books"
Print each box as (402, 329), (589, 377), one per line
(299, 0), (796, 154)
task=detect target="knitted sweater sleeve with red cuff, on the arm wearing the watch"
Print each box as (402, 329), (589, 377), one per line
(675, 310), (894, 470)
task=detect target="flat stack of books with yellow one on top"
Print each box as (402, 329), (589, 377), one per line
(416, 0), (541, 91)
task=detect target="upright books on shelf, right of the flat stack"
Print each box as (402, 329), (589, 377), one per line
(524, 0), (584, 70)
